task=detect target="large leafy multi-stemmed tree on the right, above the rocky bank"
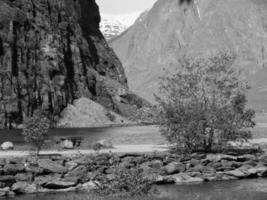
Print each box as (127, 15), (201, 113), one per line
(156, 53), (255, 152)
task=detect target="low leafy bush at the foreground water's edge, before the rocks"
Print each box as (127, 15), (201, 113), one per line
(97, 166), (151, 196)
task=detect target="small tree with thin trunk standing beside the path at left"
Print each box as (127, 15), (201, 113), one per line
(22, 111), (50, 156)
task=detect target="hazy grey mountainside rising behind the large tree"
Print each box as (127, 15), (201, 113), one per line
(110, 0), (267, 111)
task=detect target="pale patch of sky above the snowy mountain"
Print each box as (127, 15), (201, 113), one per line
(96, 0), (156, 14)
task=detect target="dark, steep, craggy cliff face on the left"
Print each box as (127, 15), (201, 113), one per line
(0, 0), (131, 125)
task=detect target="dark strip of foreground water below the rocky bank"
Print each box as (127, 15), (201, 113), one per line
(6, 179), (267, 200)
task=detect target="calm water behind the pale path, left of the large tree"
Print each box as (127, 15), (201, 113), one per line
(0, 126), (165, 148)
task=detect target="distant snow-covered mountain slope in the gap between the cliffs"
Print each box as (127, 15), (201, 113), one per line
(100, 12), (140, 41)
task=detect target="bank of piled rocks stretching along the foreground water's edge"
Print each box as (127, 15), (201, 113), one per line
(0, 152), (267, 197)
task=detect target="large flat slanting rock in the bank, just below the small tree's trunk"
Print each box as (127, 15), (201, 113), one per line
(38, 159), (68, 174)
